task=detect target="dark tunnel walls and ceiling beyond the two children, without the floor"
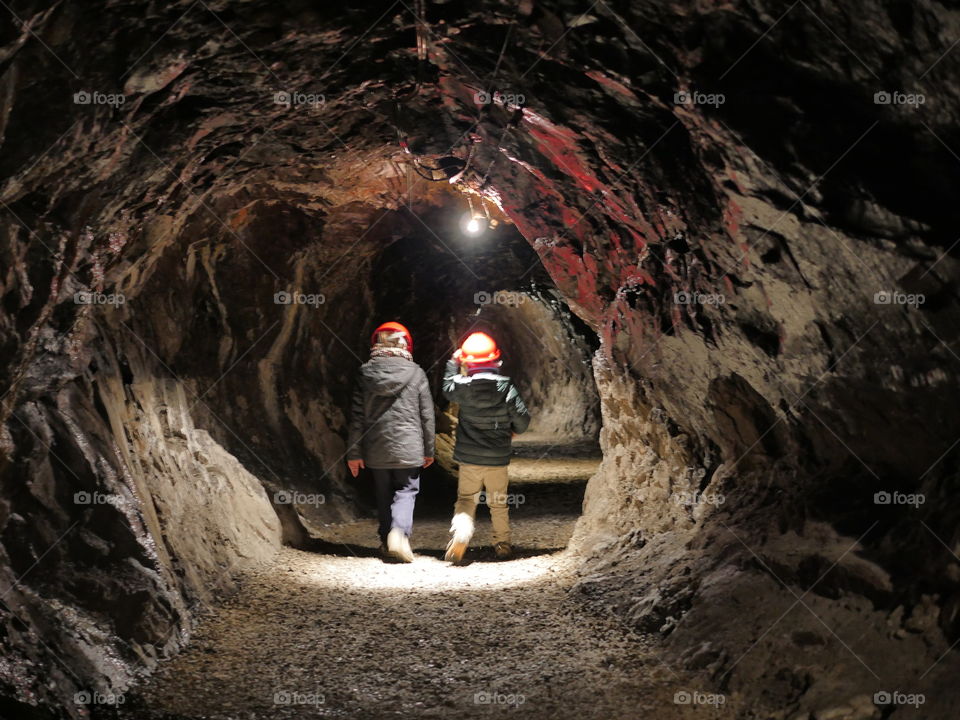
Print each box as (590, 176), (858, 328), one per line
(342, 196), (600, 528)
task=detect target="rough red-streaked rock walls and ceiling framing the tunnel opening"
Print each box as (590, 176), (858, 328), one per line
(0, 0), (960, 717)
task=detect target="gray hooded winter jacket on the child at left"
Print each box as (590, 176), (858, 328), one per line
(347, 357), (434, 468)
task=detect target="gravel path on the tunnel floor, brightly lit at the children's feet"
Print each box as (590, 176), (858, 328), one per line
(112, 448), (702, 720)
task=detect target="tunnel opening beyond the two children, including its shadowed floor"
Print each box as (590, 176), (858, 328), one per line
(308, 193), (601, 557)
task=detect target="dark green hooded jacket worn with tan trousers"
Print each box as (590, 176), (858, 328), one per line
(443, 360), (530, 465)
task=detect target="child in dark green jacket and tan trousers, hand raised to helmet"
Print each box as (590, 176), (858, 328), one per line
(443, 332), (530, 564)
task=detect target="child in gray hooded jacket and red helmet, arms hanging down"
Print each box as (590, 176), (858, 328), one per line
(347, 322), (435, 562)
